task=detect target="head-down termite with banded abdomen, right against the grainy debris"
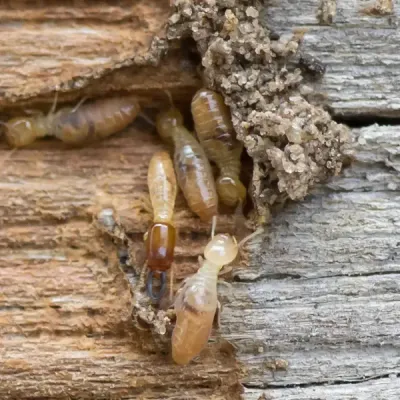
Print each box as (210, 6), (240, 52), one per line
(191, 89), (246, 207)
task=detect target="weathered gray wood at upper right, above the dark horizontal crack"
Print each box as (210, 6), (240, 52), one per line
(263, 0), (400, 118)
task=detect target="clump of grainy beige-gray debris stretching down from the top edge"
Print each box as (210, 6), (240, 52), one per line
(162, 0), (349, 219)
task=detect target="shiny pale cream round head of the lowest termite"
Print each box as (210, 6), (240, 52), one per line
(204, 233), (239, 266)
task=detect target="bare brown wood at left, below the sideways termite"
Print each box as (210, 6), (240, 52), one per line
(0, 126), (242, 399)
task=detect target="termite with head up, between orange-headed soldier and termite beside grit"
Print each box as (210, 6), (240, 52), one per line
(157, 108), (218, 222)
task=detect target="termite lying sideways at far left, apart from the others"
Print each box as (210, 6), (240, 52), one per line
(4, 96), (140, 147)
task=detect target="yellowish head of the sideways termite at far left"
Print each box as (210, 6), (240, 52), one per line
(4, 117), (47, 147)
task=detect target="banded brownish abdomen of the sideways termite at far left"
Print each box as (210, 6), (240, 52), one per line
(53, 96), (140, 145)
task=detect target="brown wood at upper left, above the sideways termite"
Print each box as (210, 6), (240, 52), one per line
(0, 0), (200, 113)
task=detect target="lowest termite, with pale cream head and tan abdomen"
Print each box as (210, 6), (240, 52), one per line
(172, 234), (238, 365)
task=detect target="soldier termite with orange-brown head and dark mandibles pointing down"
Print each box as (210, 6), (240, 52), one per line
(145, 151), (178, 300)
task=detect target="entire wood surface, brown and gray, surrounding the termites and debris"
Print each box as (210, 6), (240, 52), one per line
(0, 0), (400, 400)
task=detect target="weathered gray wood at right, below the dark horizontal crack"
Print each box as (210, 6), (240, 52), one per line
(222, 125), (400, 400)
